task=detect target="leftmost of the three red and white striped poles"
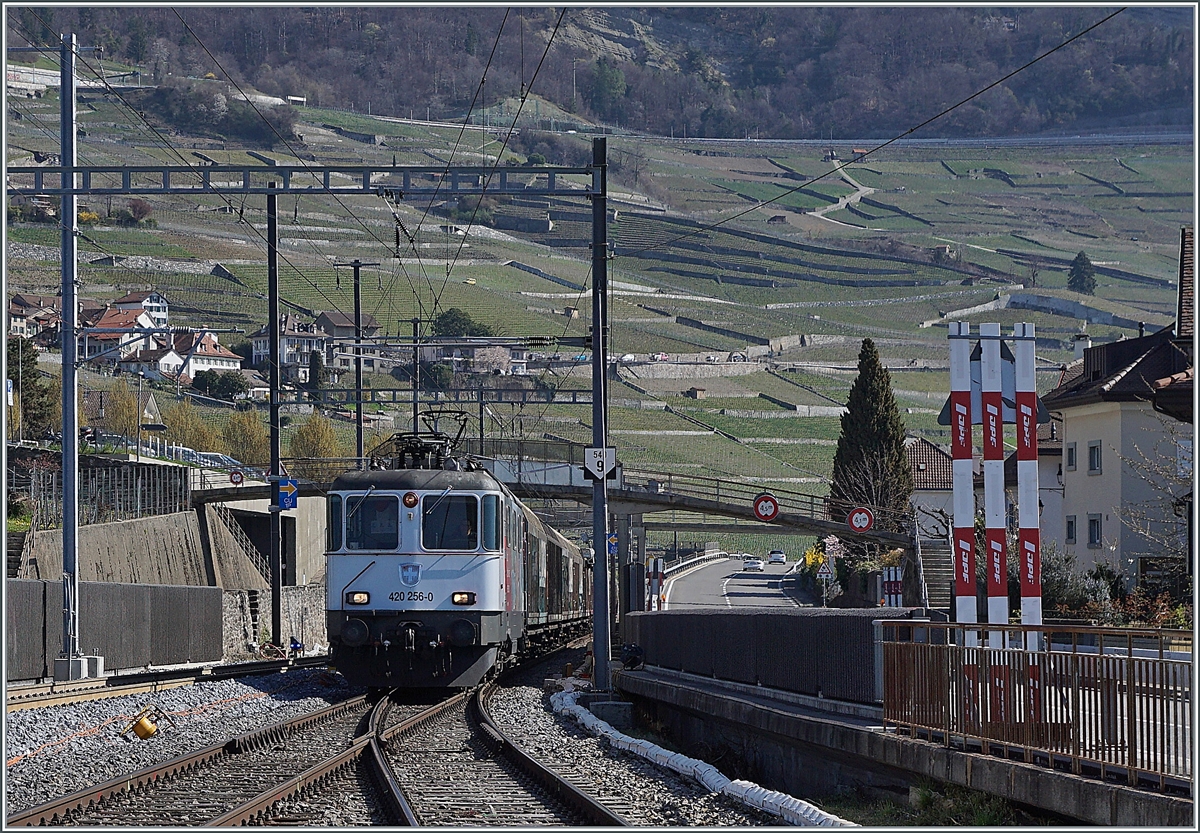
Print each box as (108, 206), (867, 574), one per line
(950, 322), (979, 726)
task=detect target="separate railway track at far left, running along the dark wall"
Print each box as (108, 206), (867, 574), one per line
(5, 657), (329, 712)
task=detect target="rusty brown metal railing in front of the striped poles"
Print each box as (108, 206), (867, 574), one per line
(881, 621), (1193, 795)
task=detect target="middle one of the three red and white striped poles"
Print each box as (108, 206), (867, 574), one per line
(979, 324), (1009, 723)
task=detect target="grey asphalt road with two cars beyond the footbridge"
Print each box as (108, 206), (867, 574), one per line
(665, 558), (799, 610)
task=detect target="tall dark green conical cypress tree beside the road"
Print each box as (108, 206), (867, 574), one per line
(829, 338), (913, 542)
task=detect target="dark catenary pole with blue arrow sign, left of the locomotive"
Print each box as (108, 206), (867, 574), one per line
(267, 182), (283, 645)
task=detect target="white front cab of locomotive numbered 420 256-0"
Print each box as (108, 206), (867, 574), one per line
(326, 463), (523, 688)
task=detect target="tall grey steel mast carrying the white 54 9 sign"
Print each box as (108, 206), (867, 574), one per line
(592, 138), (612, 691)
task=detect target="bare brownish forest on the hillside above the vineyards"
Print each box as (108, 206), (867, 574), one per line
(7, 5), (1194, 138)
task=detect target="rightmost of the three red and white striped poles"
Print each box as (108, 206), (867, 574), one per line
(1013, 324), (1042, 720)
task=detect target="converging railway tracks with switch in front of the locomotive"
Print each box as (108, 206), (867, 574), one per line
(7, 652), (628, 827)
